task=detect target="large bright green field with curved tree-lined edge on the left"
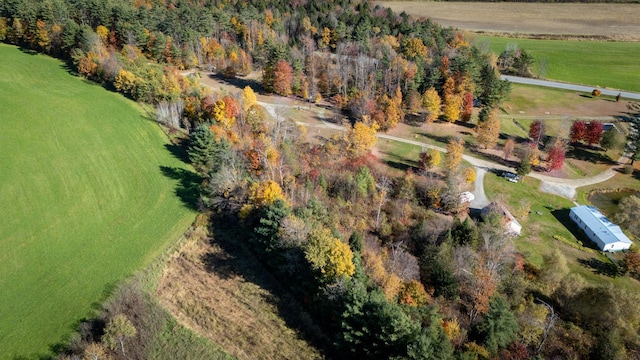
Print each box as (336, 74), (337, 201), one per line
(0, 45), (195, 358)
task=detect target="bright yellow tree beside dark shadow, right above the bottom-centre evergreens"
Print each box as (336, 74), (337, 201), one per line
(304, 227), (356, 282)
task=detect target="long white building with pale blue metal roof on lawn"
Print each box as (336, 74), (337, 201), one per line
(569, 205), (631, 252)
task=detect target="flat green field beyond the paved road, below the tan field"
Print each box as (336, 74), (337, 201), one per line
(476, 36), (640, 92)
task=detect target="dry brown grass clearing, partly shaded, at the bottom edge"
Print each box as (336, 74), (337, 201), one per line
(158, 229), (322, 359)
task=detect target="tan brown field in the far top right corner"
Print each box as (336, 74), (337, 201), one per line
(378, 1), (640, 41)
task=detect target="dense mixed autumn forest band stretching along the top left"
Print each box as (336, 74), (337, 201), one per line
(0, 0), (509, 130)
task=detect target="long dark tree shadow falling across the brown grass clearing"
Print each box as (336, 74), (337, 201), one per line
(202, 218), (335, 355)
